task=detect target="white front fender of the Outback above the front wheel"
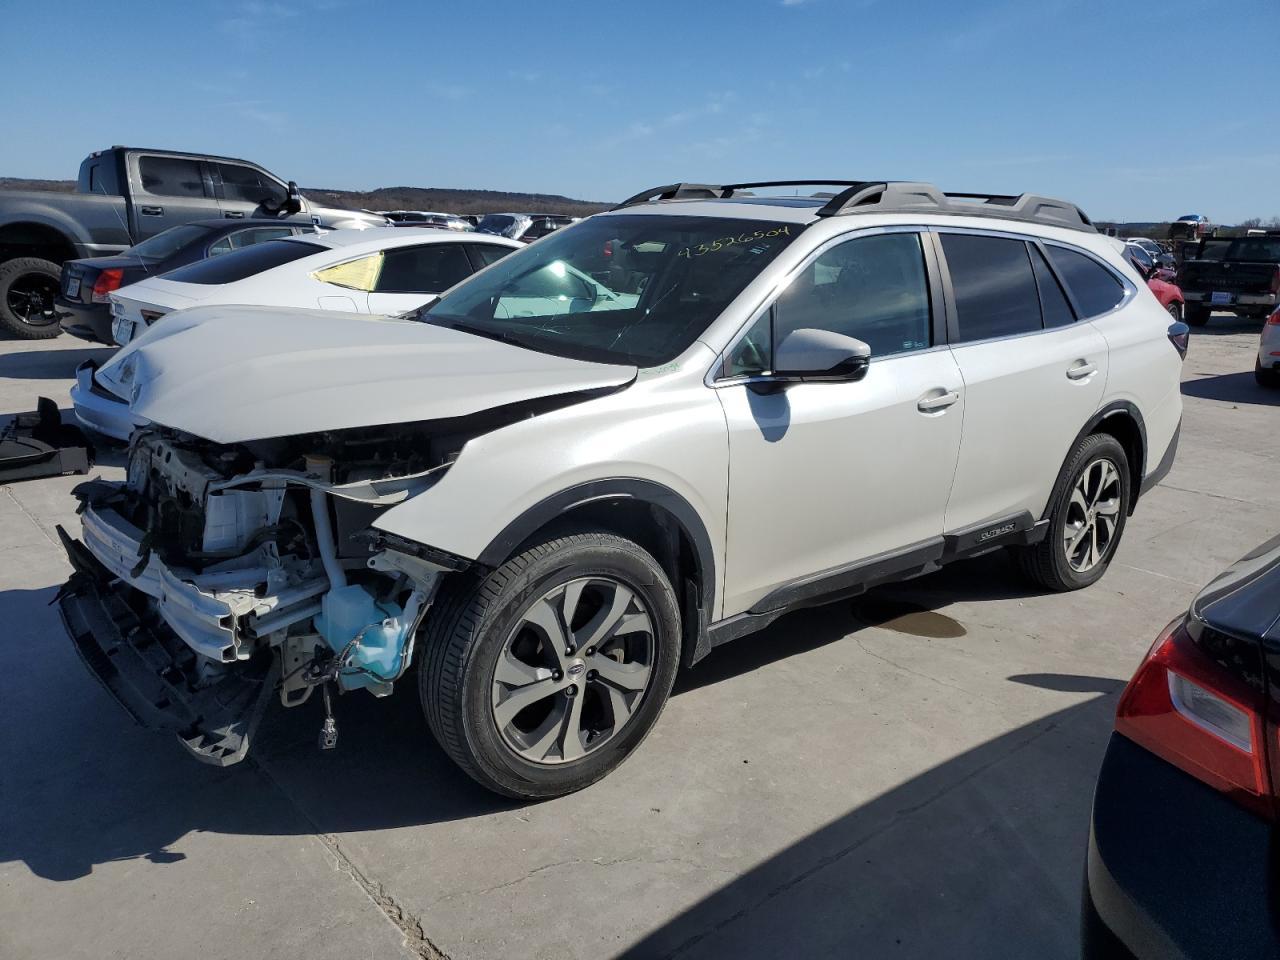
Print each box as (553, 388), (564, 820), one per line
(375, 358), (728, 616)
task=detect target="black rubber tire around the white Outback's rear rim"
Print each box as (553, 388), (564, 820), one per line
(1014, 434), (1133, 591)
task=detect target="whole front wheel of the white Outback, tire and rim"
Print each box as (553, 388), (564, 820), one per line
(419, 532), (680, 800)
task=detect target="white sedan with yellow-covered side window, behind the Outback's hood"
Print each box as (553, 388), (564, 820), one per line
(104, 227), (524, 347)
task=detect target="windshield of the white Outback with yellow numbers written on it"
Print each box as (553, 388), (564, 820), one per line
(424, 215), (803, 366)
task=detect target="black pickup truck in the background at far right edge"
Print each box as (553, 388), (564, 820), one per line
(1178, 230), (1280, 326)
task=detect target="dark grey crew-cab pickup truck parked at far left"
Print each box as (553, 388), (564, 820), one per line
(0, 146), (387, 339)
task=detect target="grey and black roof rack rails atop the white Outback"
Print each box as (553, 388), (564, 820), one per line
(613, 180), (1097, 233)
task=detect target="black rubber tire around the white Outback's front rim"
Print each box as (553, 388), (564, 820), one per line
(419, 532), (681, 800)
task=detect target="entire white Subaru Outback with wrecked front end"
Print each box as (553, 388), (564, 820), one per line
(59, 182), (1187, 797)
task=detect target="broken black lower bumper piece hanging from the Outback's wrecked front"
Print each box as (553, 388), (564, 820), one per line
(58, 527), (279, 767)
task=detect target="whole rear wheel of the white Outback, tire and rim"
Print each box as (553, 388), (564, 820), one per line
(1015, 434), (1132, 590)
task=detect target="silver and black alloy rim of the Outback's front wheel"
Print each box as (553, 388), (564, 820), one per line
(492, 576), (657, 764)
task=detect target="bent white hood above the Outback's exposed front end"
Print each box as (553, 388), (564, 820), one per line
(107, 306), (636, 443)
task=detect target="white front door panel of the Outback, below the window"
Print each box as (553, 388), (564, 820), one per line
(717, 349), (964, 616)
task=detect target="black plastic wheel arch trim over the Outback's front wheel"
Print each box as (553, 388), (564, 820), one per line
(476, 477), (716, 666)
